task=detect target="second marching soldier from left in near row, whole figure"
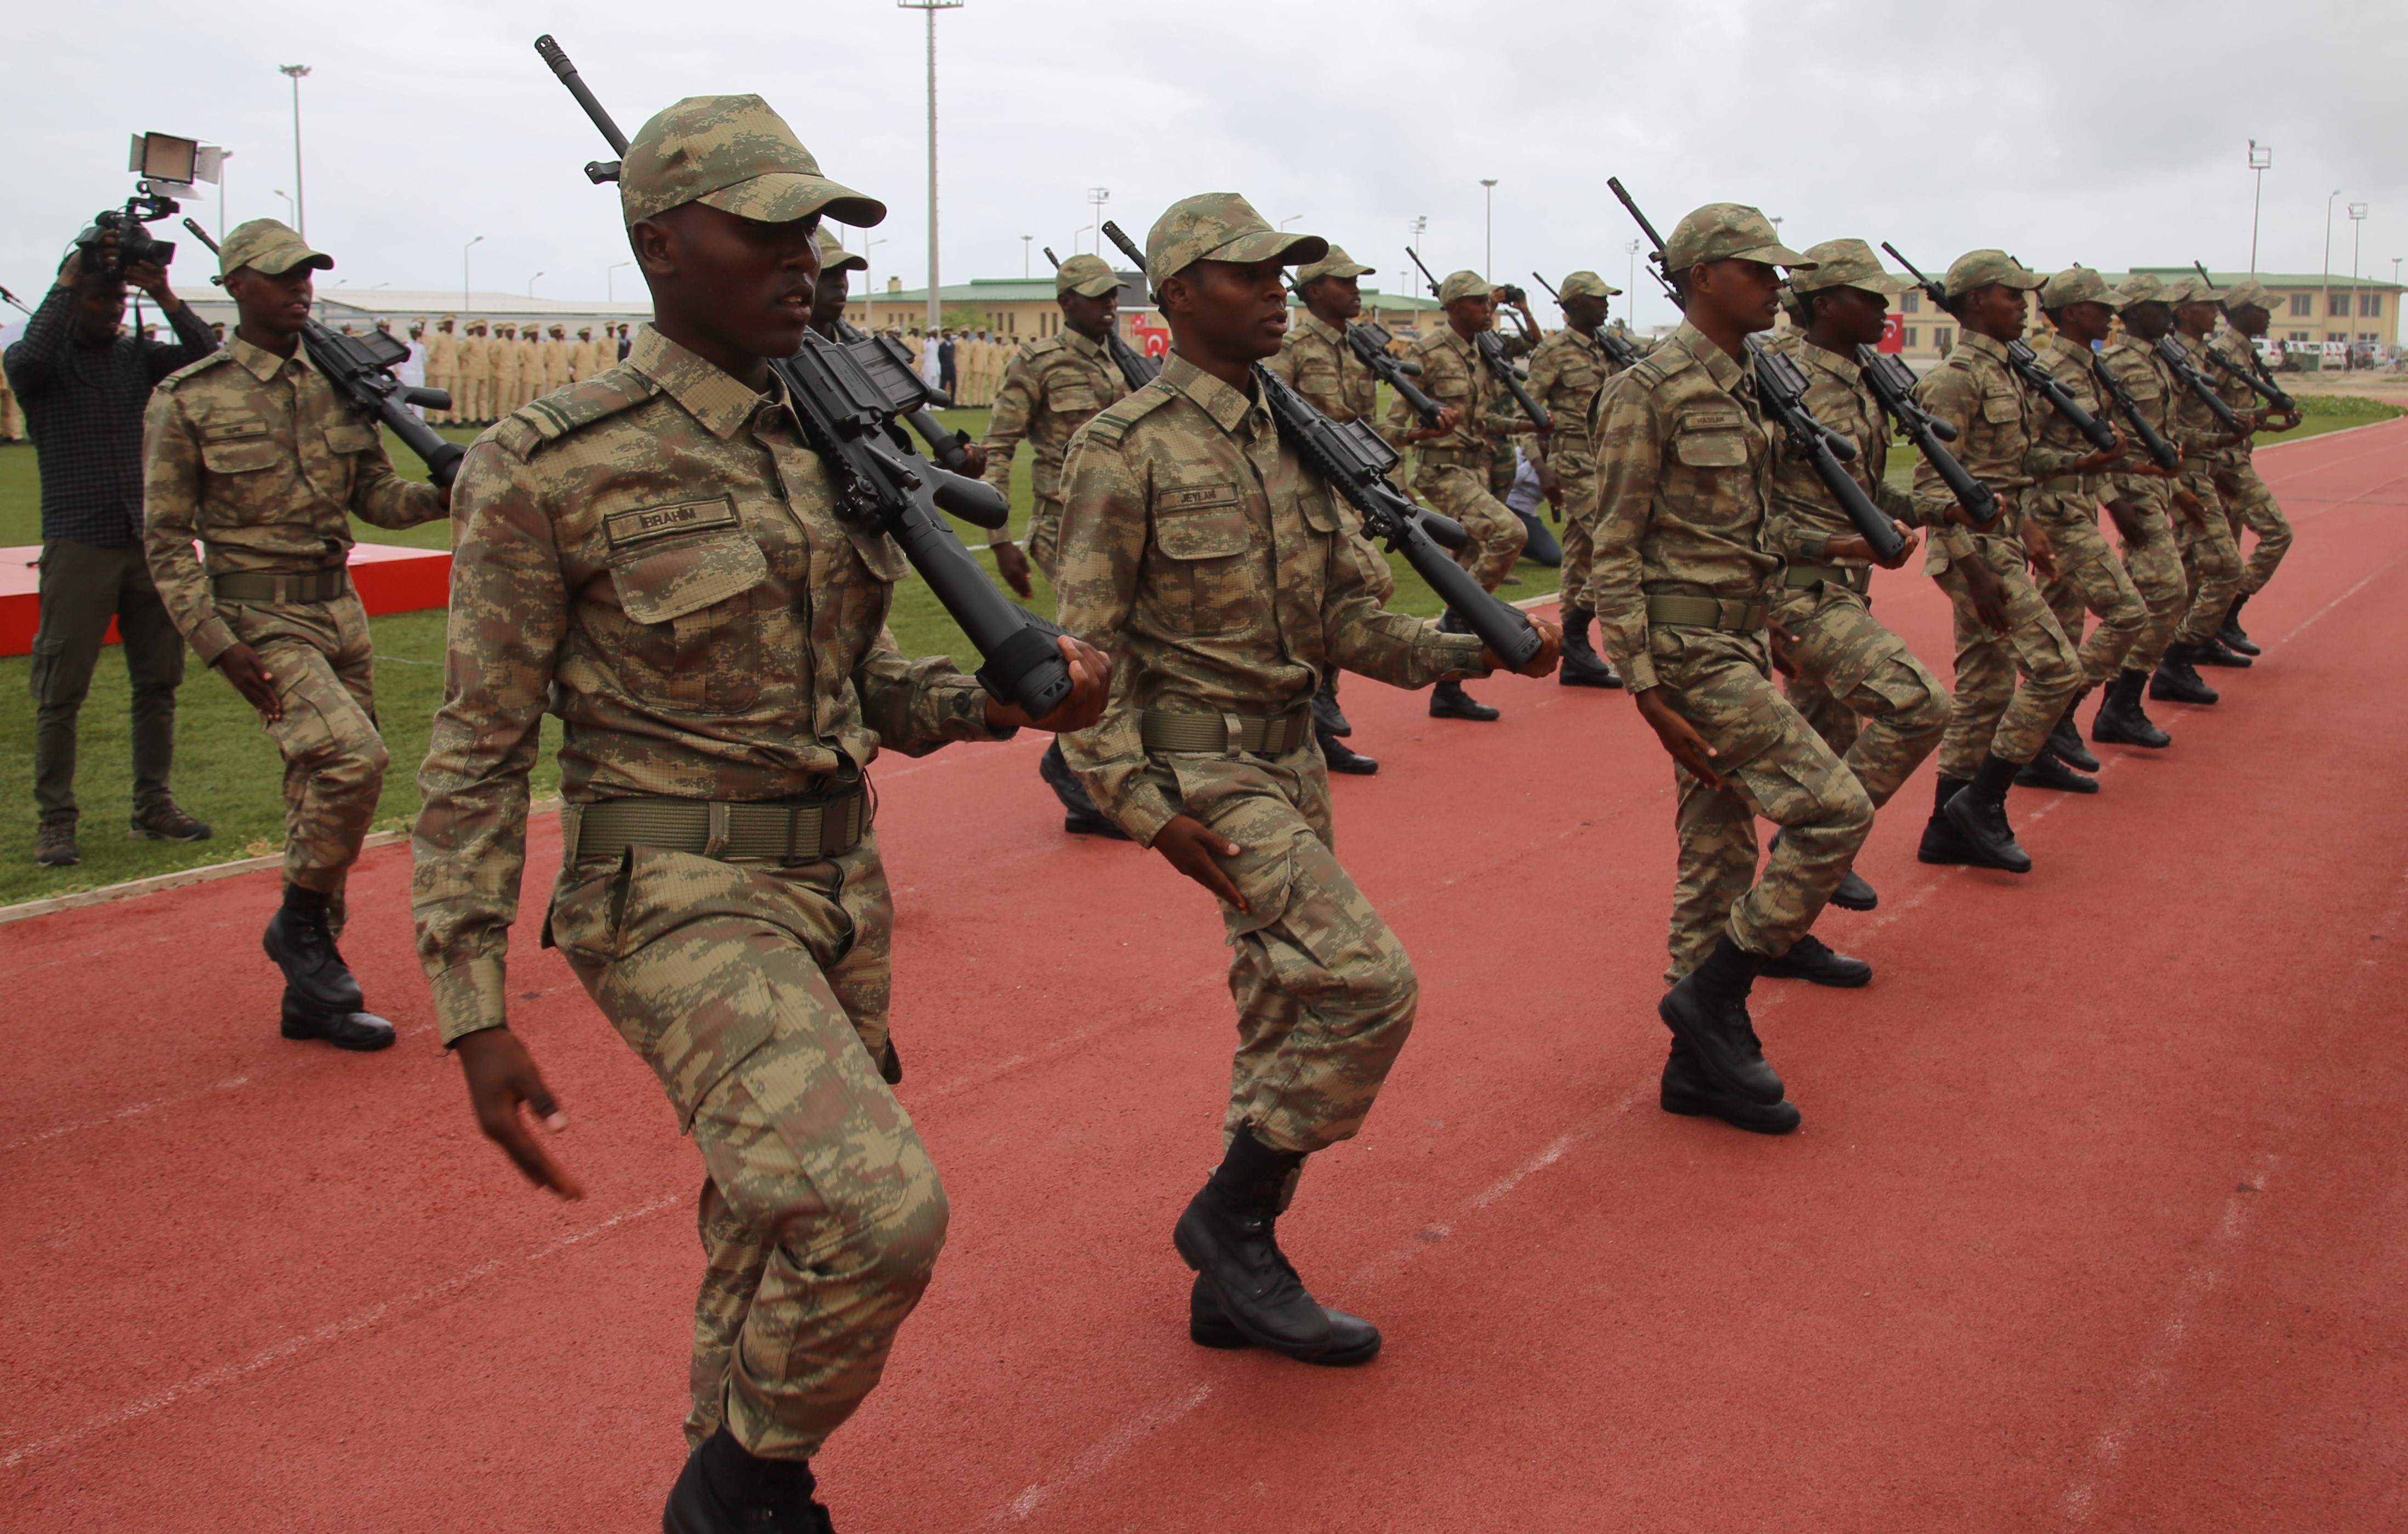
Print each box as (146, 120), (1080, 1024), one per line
(1059, 192), (1555, 1366)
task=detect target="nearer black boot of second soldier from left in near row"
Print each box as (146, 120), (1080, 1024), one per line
(1171, 1129), (1380, 1363)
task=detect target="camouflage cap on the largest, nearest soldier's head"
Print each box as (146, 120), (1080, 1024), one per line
(619, 96), (886, 229)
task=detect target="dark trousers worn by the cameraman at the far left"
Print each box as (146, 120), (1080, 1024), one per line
(33, 539), (183, 821)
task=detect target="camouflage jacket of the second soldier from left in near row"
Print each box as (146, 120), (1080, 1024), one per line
(1059, 354), (1481, 845)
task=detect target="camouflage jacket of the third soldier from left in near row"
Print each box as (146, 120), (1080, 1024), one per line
(1589, 320), (1780, 691)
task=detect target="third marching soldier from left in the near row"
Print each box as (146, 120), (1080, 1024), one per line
(1589, 202), (1873, 1134)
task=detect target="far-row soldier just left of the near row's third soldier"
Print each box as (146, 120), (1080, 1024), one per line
(1522, 272), (1623, 686)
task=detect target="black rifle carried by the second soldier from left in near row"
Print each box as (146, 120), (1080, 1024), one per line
(1103, 224), (1541, 667)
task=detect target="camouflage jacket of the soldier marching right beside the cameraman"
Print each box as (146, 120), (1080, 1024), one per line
(142, 335), (443, 664)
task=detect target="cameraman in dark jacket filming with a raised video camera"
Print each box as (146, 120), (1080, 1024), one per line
(7, 229), (217, 867)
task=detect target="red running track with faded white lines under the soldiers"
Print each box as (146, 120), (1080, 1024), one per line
(0, 422), (2408, 1534)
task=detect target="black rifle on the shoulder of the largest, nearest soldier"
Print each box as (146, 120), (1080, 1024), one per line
(535, 33), (1071, 718)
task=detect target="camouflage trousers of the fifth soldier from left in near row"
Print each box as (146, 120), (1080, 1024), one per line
(1936, 537), (2083, 783)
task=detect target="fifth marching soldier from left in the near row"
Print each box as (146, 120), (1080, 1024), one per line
(1915, 251), (2117, 874)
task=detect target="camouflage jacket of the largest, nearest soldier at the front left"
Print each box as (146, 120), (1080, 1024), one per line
(414, 325), (1009, 1043)
